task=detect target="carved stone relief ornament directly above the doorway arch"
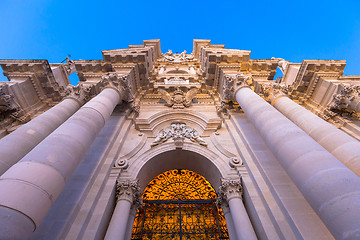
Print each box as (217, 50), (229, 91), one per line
(151, 122), (207, 147)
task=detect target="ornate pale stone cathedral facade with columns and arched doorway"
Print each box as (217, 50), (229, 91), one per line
(0, 40), (360, 240)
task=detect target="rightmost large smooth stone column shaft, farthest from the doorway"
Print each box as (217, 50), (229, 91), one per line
(271, 95), (360, 176)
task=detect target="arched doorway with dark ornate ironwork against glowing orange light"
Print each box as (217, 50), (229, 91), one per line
(131, 169), (229, 240)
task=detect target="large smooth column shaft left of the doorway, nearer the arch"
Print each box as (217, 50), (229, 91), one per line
(0, 87), (122, 239)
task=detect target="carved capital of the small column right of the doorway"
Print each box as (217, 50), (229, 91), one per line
(217, 179), (243, 202)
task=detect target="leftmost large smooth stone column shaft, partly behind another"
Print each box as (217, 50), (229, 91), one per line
(0, 98), (81, 175)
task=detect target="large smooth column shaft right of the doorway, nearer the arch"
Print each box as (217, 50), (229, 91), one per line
(234, 87), (360, 239)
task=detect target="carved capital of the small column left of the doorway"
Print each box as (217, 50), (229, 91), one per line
(116, 180), (142, 205)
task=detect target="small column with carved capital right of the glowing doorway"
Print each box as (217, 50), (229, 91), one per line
(219, 179), (257, 240)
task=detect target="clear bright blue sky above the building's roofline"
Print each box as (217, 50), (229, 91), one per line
(0, 0), (360, 83)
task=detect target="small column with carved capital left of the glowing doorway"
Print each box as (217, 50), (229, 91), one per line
(105, 181), (140, 240)
